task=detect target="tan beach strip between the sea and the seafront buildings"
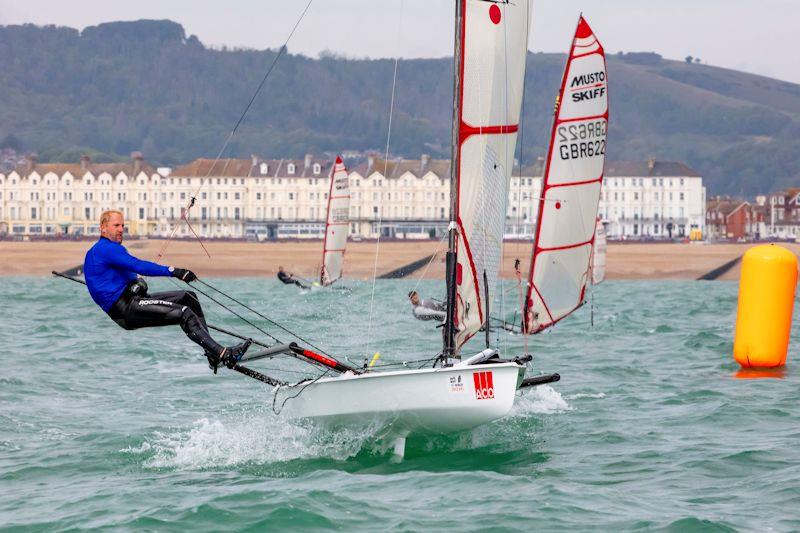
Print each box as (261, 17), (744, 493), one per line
(0, 240), (800, 280)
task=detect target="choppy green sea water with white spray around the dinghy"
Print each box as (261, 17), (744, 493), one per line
(0, 277), (800, 531)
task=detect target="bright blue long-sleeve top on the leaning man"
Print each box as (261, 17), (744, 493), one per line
(83, 237), (172, 312)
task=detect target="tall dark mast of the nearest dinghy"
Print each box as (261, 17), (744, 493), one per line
(442, 0), (464, 362)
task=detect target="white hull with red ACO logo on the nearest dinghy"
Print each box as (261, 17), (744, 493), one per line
(277, 363), (524, 435)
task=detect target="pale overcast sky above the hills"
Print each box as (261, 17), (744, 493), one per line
(0, 0), (800, 83)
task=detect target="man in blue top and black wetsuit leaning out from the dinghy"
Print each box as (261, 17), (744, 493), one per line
(83, 211), (251, 373)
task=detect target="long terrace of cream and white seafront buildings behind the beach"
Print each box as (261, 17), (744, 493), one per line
(0, 152), (706, 240)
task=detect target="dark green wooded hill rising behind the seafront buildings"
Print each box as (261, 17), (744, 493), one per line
(0, 21), (800, 196)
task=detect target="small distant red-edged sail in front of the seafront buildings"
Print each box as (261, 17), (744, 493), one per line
(320, 157), (350, 286)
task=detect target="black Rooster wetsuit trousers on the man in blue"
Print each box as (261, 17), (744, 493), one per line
(108, 285), (224, 354)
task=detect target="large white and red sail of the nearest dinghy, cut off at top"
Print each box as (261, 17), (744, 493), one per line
(454, 0), (530, 350)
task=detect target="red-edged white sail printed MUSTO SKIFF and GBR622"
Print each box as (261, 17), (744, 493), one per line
(523, 17), (608, 333)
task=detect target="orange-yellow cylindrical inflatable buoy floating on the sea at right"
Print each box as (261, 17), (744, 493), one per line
(733, 244), (797, 368)
